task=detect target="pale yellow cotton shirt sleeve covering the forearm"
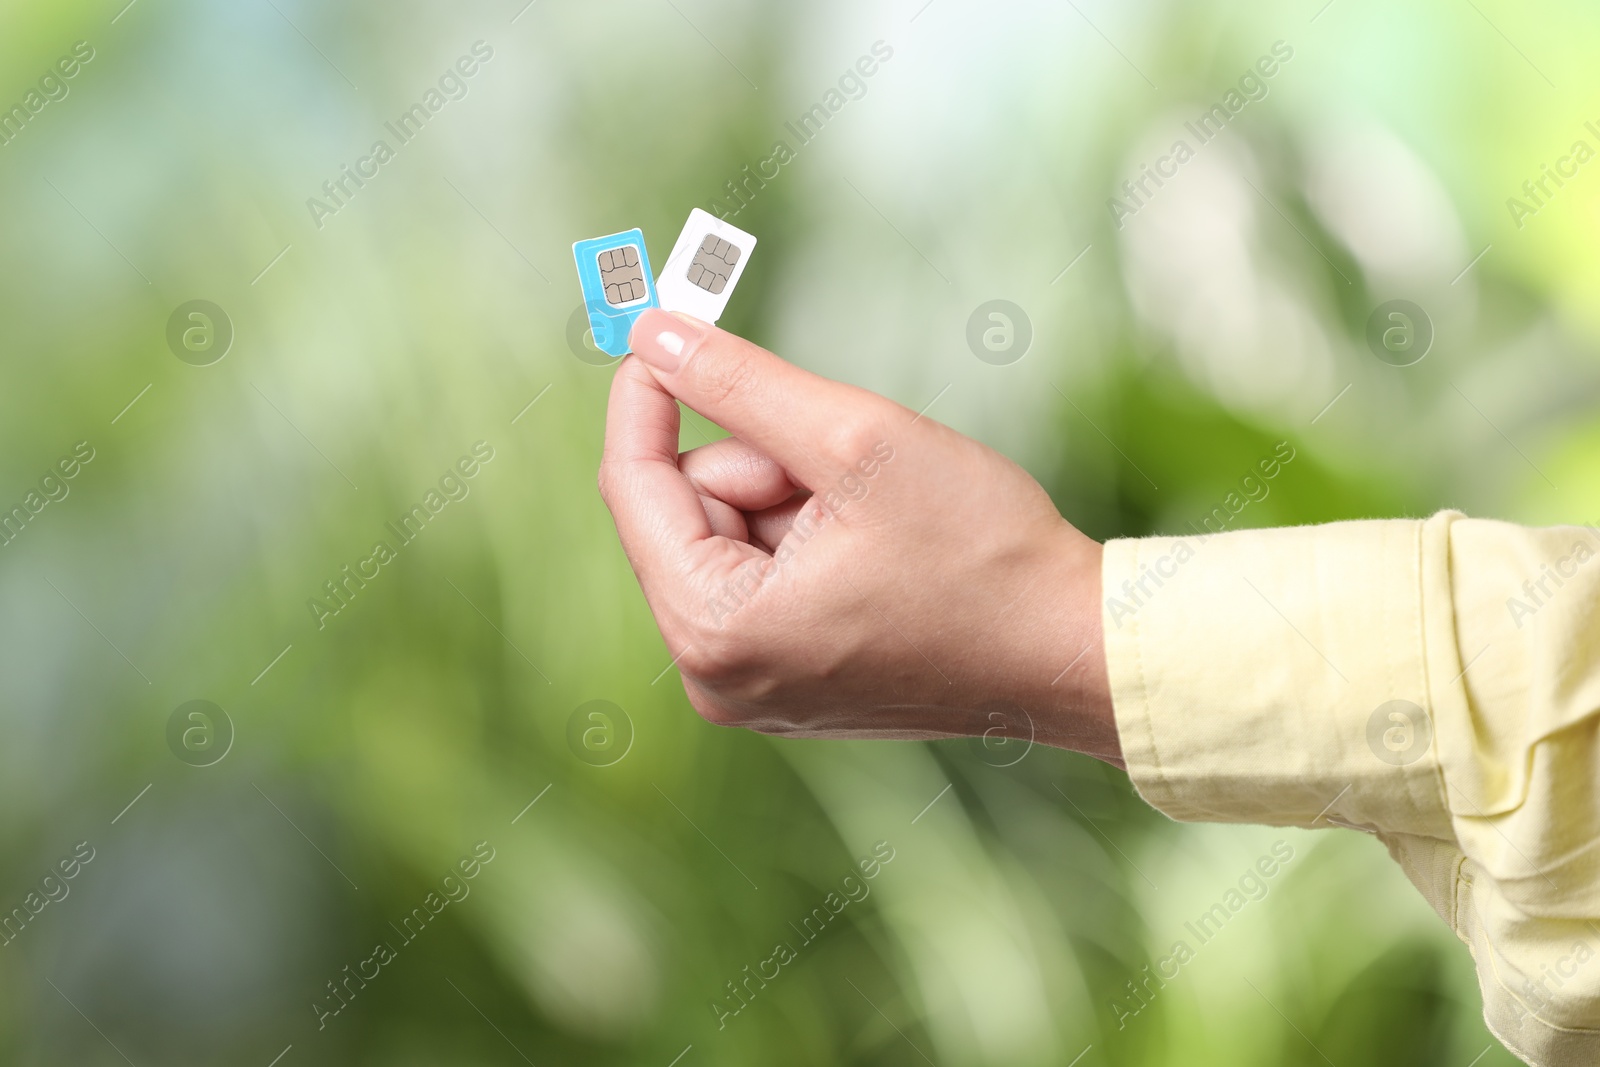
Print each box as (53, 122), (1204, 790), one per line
(1102, 512), (1600, 1067)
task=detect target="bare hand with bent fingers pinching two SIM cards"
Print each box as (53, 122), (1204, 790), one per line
(600, 310), (1122, 766)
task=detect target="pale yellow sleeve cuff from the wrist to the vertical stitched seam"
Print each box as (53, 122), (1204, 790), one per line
(1102, 514), (1464, 840)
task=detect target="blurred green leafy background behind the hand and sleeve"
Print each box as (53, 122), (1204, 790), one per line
(0, 0), (1600, 1067)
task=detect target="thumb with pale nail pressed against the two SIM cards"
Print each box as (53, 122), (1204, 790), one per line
(630, 309), (909, 490)
